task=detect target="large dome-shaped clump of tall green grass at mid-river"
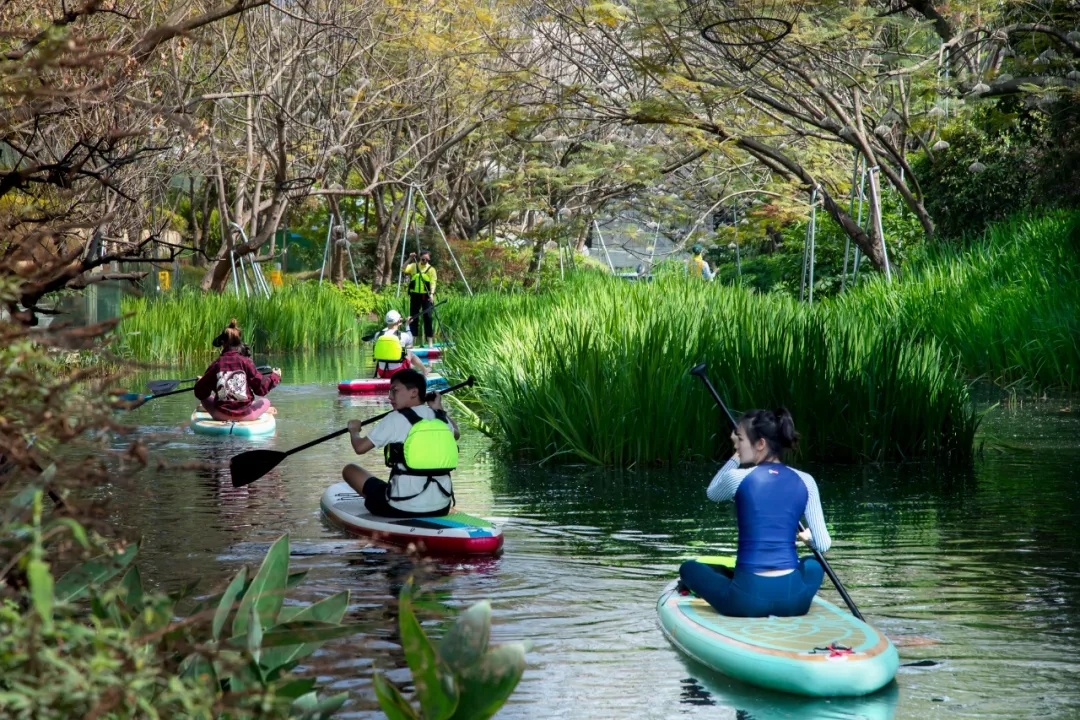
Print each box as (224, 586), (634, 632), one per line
(446, 274), (977, 466)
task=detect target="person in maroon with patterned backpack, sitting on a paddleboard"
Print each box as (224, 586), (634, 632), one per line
(194, 320), (281, 422)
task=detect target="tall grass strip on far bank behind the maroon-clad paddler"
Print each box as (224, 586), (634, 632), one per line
(119, 283), (361, 362)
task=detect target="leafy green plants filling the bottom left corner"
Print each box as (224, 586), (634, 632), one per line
(0, 487), (359, 720)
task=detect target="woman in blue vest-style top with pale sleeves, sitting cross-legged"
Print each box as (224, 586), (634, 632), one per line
(679, 408), (832, 617)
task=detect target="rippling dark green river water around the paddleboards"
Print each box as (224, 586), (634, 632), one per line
(100, 354), (1080, 720)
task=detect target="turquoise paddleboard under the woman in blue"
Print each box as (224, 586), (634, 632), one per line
(657, 558), (900, 697)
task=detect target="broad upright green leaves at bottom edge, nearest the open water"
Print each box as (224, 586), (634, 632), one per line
(375, 586), (526, 720)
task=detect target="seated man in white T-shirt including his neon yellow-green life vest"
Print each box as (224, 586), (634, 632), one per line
(341, 370), (459, 518)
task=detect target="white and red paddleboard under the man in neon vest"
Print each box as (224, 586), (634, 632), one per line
(320, 483), (502, 555)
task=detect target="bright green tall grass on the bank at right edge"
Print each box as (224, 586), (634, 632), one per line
(835, 212), (1080, 390)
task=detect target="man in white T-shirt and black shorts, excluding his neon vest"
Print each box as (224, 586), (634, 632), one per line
(341, 370), (460, 518)
